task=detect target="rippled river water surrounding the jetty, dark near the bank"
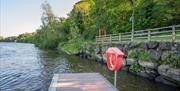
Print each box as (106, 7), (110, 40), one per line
(0, 42), (180, 91)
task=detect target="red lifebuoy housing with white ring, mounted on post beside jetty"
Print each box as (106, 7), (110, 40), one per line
(106, 47), (124, 71)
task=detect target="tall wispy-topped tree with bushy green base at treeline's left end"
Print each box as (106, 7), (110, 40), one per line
(33, 2), (67, 49)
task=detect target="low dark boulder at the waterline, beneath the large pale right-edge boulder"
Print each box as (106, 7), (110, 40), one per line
(155, 76), (178, 87)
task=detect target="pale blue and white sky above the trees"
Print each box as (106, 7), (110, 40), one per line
(0, 0), (79, 37)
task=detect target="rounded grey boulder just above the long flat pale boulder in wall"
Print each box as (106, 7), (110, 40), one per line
(148, 49), (161, 61)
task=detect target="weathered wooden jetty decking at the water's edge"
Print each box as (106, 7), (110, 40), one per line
(49, 73), (118, 91)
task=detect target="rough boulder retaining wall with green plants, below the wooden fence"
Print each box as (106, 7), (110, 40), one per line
(80, 42), (180, 87)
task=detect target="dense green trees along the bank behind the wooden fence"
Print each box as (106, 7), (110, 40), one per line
(1, 0), (180, 50)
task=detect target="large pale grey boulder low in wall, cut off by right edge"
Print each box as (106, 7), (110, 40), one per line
(158, 65), (180, 82)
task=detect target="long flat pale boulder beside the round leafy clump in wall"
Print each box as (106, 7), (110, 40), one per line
(138, 61), (158, 69)
